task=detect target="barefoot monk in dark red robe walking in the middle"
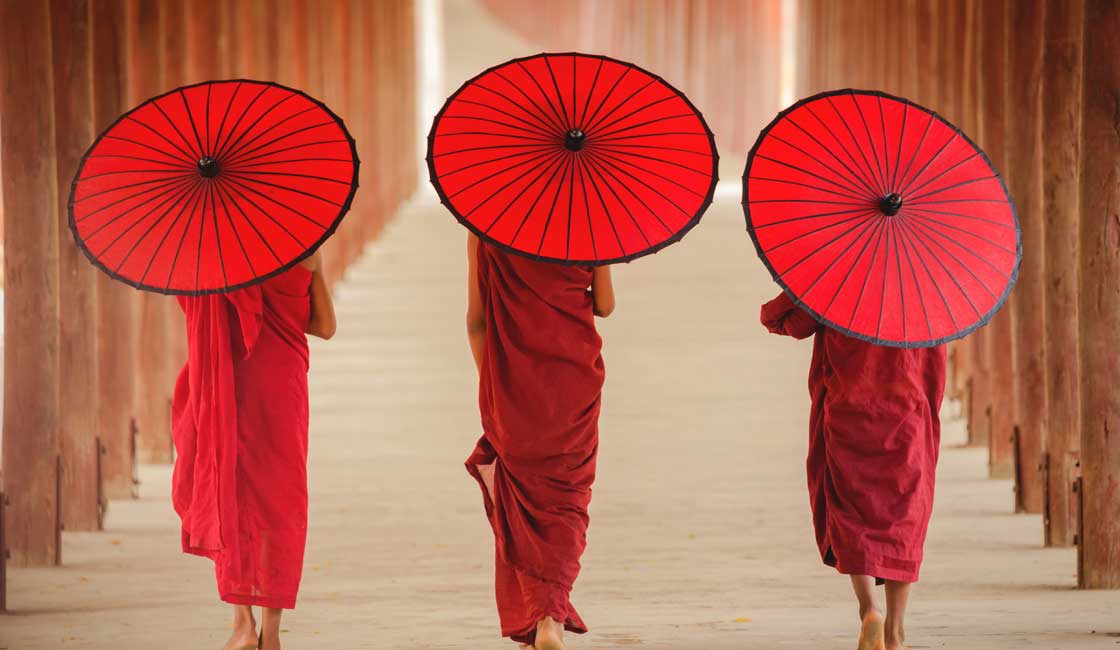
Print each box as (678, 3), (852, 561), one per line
(466, 235), (615, 650)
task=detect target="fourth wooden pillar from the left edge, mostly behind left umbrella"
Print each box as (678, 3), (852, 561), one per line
(125, 0), (172, 463)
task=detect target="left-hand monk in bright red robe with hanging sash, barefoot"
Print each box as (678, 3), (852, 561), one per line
(171, 253), (335, 650)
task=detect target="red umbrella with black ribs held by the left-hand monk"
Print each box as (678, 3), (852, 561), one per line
(69, 80), (358, 295)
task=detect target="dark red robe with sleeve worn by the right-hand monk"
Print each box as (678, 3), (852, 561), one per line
(762, 294), (945, 583)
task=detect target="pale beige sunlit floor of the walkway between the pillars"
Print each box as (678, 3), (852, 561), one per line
(0, 1), (1120, 650)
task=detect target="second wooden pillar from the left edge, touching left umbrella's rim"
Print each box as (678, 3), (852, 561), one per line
(50, 0), (102, 530)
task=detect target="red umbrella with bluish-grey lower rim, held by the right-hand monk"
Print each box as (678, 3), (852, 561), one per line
(743, 90), (1021, 347)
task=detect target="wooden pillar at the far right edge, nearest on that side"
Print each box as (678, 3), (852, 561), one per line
(1075, 0), (1120, 588)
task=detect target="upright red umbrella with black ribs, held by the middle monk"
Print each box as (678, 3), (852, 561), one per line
(428, 53), (719, 264)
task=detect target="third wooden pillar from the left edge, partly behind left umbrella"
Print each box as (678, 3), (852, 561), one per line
(90, 0), (137, 499)
